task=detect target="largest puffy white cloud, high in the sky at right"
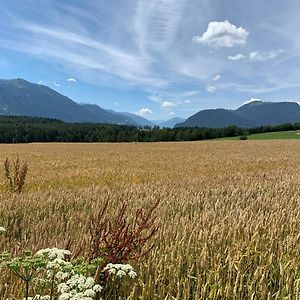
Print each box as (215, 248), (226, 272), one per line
(193, 20), (249, 48)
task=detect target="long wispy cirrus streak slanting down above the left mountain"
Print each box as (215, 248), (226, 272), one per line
(15, 22), (166, 86)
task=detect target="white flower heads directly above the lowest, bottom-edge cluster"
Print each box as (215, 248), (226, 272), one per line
(35, 247), (72, 281)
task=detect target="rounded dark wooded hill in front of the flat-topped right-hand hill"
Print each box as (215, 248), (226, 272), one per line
(175, 109), (255, 128)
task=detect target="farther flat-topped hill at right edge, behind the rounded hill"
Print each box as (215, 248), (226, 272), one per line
(234, 101), (300, 125)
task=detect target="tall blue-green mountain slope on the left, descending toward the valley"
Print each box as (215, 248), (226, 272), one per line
(0, 79), (137, 126)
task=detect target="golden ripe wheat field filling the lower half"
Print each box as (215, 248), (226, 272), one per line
(0, 140), (300, 300)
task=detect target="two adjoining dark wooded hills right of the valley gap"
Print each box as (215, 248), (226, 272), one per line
(175, 101), (300, 128)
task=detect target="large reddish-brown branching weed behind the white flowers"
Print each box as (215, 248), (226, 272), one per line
(89, 201), (159, 296)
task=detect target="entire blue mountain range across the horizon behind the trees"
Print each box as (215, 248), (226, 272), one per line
(0, 79), (300, 128)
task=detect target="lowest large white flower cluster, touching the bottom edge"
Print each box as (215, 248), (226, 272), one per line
(58, 274), (102, 300)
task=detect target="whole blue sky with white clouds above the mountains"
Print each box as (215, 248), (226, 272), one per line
(0, 0), (300, 120)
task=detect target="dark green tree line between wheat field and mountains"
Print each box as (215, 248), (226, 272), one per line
(0, 116), (300, 143)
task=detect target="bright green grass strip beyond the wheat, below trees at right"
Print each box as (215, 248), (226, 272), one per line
(221, 130), (300, 140)
